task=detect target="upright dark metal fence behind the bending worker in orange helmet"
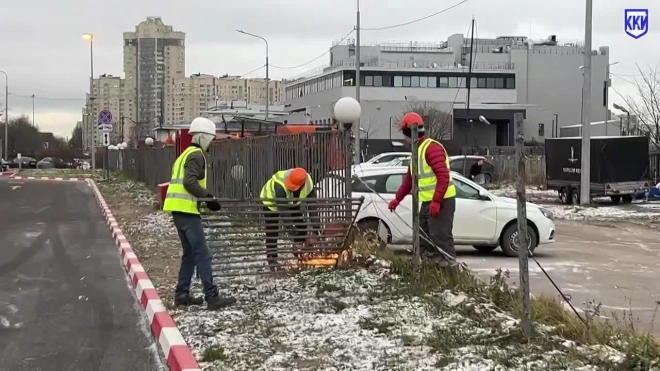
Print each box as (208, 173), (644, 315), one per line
(208, 131), (351, 199)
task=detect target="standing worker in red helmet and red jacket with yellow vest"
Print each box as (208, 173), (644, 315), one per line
(389, 112), (456, 265)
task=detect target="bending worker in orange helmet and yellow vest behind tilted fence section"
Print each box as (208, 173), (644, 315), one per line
(259, 167), (321, 270)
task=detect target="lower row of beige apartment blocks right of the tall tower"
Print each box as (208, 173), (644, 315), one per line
(165, 74), (284, 125)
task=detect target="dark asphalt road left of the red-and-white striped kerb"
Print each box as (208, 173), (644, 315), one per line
(0, 178), (164, 371)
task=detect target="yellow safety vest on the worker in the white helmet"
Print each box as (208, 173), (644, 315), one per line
(163, 146), (208, 215)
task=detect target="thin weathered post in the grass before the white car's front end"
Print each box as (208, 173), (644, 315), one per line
(513, 113), (532, 339)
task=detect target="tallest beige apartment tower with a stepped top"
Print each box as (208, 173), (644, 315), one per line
(124, 17), (186, 140)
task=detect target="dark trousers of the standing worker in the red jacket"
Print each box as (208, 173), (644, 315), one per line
(419, 197), (456, 260)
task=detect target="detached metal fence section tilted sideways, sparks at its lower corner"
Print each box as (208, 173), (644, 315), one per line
(202, 198), (363, 278)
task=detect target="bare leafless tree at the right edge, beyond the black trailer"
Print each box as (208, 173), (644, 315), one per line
(615, 65), (660, 144)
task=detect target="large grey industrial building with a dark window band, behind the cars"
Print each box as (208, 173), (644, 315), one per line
(285, 34), (610, 152)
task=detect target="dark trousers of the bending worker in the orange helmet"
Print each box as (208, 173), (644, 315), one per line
(264, 208), (306, 263)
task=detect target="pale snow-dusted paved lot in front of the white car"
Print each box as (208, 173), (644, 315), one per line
(457, 221), (660, 335)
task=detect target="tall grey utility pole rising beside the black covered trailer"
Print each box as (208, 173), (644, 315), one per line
(580, 0), (593, 205)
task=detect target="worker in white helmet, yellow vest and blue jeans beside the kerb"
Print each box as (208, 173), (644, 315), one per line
(163, 117), (236, 310)
